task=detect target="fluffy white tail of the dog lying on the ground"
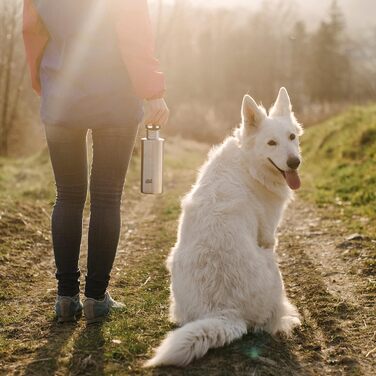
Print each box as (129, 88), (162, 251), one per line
(144, 315), (247, 367)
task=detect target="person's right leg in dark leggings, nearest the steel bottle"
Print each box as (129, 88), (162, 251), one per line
(85, 125), (138, 300)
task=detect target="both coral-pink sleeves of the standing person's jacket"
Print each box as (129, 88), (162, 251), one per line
(23, 0), (165, 99)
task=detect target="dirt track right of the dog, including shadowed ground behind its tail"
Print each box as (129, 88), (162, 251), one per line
(151, 198), (376, 376)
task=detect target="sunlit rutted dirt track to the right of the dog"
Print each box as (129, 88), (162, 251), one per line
(279, 199), (376, 375)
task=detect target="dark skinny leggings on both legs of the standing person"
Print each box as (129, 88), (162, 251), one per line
(45, 125), (138, 299)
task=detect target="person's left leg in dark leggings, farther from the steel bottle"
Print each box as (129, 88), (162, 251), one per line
(45, 125), (87, 297)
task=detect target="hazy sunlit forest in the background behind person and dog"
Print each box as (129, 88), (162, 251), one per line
(0, 0), (376, 155)
